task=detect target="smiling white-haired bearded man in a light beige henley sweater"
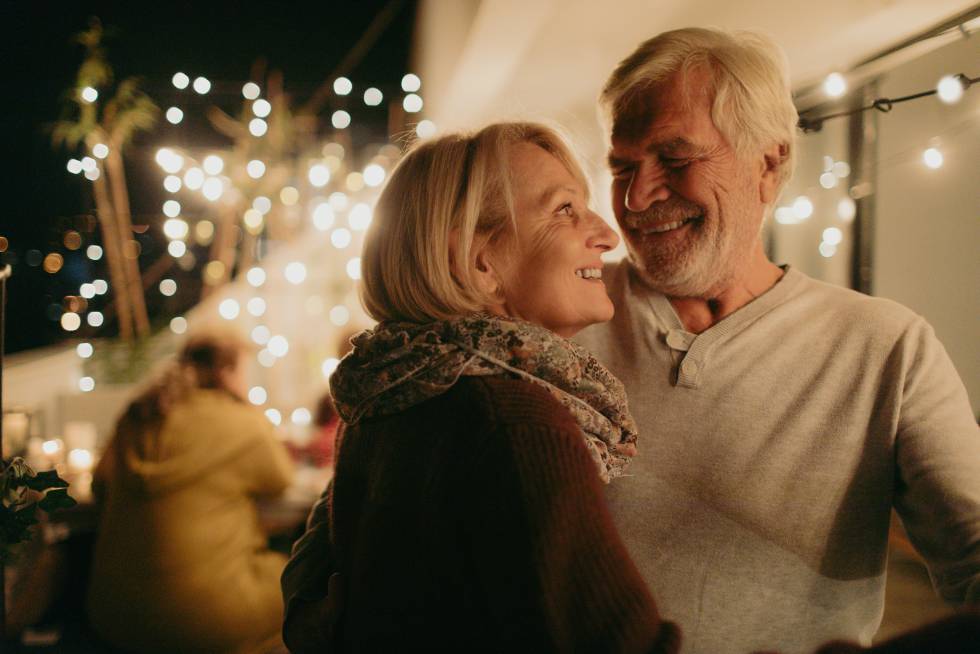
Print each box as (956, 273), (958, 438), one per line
(579, 29), (980, 654)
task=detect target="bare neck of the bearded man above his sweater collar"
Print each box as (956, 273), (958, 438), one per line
(667, 247), (783, 334)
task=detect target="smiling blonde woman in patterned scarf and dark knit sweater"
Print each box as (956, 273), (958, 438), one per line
(283, 123), (678, 652)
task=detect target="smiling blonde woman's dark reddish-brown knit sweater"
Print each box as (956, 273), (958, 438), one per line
(284, 377), (679, 653)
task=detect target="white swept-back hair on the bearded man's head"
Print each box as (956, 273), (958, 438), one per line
(599, 27), (798, 191)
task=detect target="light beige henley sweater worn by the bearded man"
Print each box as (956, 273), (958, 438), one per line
(576, 261), (980, 654)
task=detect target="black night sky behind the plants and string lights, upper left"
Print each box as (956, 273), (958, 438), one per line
(0, 0), (416, 353)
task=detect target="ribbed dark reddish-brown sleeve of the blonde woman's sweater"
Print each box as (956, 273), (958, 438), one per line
(466, 398), (679, 653)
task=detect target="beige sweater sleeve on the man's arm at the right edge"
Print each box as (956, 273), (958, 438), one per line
(892, 319), (980, 604)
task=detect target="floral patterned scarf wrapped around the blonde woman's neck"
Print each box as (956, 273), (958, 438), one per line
(330, 313), (637, 483)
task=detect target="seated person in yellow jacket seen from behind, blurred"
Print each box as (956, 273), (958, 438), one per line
(86, 331), (292, 653)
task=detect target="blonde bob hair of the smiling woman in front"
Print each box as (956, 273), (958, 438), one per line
(360, 122), (588, 323)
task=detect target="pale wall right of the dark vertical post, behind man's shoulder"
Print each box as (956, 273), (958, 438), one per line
(873, 36), (980, 415)
